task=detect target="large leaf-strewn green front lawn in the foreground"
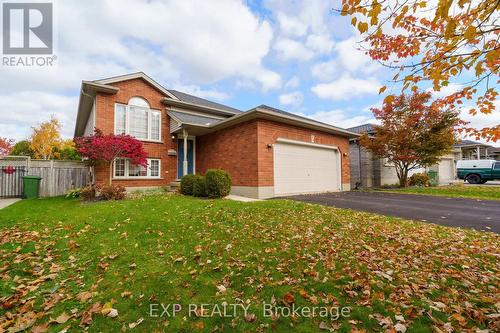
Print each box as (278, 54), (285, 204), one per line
(0, 195), (500, 332)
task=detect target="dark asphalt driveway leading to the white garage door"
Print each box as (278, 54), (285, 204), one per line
(288, 191), (500, 233)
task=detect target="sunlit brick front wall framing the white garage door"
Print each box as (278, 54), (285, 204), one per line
(257, 120), (350, 186)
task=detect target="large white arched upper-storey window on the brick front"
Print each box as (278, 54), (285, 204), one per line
(115, 97), (161, 141)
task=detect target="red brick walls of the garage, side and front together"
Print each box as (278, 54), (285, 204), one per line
(196, 120), (350, 186)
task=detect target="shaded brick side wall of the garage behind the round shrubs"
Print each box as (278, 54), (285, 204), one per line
(196, 120), (258, 186)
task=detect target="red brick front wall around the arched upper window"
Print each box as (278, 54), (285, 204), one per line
(95, 79), (177, 186)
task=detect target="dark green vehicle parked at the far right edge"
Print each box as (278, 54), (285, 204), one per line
(457, 160), (500, 184)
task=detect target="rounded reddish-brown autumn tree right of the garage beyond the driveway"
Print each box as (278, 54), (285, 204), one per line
(359, 92), (461, 187)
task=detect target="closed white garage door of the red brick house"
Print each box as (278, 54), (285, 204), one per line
(274, 141), (341, 195)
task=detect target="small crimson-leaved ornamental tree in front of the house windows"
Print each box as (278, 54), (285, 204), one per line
(74, 128), (148, 185)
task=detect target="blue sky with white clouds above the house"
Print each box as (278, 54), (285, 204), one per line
(0, 0), (500, 140)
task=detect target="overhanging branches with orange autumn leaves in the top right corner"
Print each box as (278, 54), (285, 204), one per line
(340, 0), (500, 142)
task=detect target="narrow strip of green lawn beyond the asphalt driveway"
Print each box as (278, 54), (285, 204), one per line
(378, 185), (500, 200)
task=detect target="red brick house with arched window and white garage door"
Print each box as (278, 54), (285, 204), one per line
(75, 73), (357, 198)
